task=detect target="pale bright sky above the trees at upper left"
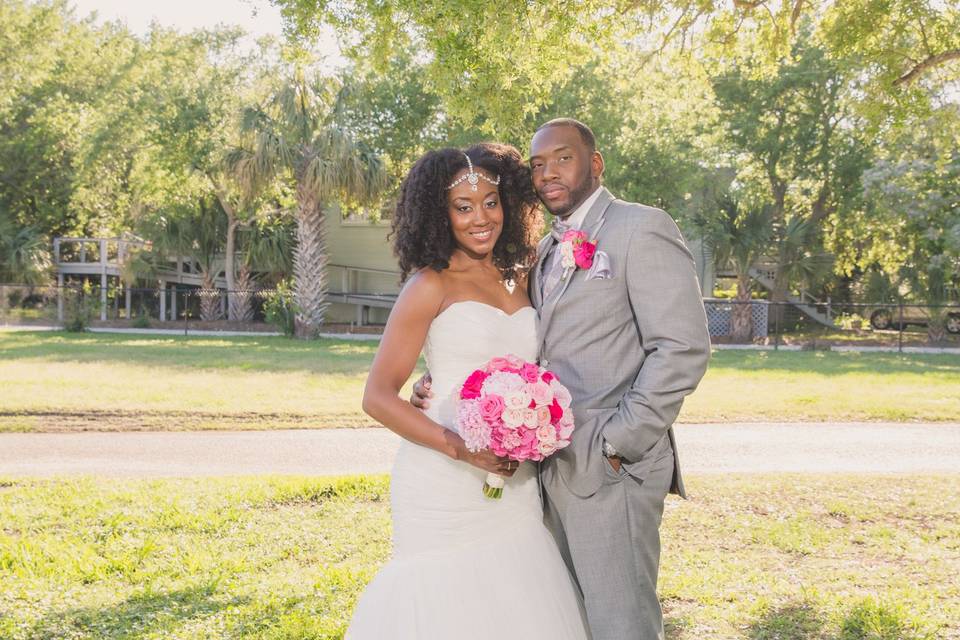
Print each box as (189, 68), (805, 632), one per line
(71, 0), (339, 57)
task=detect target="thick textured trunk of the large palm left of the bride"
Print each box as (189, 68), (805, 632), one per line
(293, 184), (328, 338)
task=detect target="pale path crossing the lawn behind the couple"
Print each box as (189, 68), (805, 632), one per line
(0, 423), (960, 477)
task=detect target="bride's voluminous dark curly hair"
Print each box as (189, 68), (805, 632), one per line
(391, 142), (543, 282)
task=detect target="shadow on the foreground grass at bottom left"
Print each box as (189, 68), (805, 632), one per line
(27, 583), (248, 640)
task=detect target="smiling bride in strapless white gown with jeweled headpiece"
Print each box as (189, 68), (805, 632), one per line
(346, 144), (587, 640)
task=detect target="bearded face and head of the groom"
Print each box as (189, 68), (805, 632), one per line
(530, 125), (603, 218)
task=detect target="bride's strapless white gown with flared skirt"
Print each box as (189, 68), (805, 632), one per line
(346, 301), (588, 640)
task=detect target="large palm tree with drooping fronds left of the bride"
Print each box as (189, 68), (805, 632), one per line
(227, 71), (387, 337)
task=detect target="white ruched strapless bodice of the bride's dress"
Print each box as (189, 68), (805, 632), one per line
(423, 300), (538, 429)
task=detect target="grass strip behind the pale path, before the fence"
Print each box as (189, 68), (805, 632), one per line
(0, 332), (960, 431)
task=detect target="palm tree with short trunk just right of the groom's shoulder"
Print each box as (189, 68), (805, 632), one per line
(708, 196), (773, 342)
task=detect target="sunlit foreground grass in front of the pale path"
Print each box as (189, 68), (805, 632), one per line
(0, 475), (960, 640)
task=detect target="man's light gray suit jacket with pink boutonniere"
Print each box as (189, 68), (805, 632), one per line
(529, 187), (710, 497)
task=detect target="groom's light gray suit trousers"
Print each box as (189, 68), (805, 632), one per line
(544, 438), (674, 640)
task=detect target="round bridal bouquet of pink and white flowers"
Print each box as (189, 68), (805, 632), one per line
(457, 355), (573, 498)
